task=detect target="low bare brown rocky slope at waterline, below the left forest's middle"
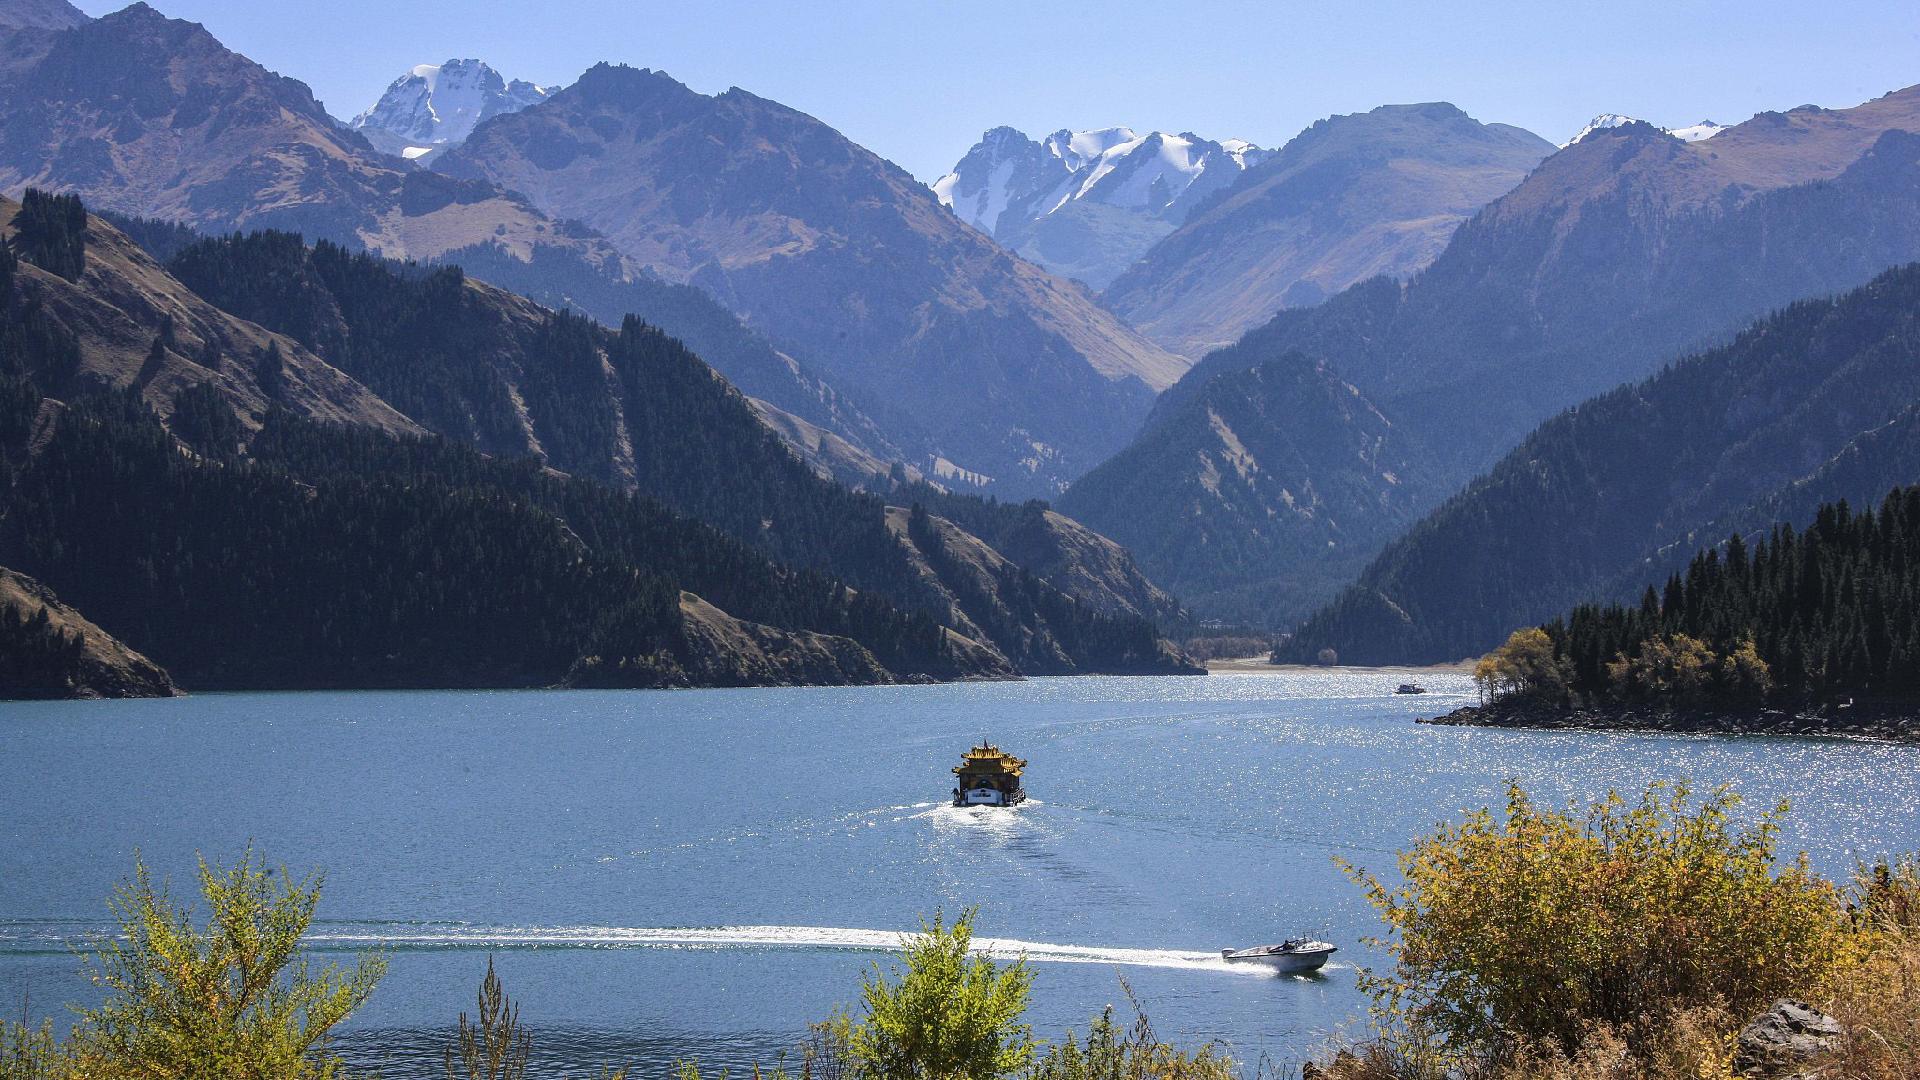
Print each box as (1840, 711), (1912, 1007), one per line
(566, 592), (893, 688)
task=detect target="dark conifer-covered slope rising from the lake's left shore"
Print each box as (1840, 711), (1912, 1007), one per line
(0, 194), (1179, 686)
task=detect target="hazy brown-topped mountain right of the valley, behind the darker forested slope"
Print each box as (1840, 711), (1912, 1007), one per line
(1062, 88), (1920, 630)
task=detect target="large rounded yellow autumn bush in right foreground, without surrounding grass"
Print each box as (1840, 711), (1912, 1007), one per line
(1350, 784), (1859, 1059)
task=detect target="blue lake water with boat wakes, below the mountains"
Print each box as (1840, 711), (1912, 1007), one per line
(0, 671), (1920, 1076)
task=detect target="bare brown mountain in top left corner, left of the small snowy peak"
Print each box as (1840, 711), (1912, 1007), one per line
(0, 4), (591, 261)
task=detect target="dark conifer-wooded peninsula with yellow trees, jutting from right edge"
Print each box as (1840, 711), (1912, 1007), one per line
(1432, 486), (1920, 740)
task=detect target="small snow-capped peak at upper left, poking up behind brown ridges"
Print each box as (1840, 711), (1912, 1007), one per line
(348, 60), (551, 161)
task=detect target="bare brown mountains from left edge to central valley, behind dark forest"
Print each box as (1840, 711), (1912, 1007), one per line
(0, 4), (1185, 494)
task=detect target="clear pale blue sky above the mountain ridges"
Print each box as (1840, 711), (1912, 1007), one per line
(81, 0), (1920, 181)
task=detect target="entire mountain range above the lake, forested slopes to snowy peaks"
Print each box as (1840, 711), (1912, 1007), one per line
(15, 0), (1920, 684)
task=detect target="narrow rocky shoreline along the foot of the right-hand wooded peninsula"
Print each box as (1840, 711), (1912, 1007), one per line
(1419, 701), (1920, 742)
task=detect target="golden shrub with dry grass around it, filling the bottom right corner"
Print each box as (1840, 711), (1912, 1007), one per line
(1309, 784), (1920, 1080)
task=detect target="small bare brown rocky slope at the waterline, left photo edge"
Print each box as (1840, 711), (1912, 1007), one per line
(0, 567), (179, 698)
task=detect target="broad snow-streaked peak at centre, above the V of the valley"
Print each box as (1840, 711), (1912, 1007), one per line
(933, 127), (1267, 288)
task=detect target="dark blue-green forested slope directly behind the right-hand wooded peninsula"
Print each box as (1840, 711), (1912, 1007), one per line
(1284, 261), (1920, 663)
